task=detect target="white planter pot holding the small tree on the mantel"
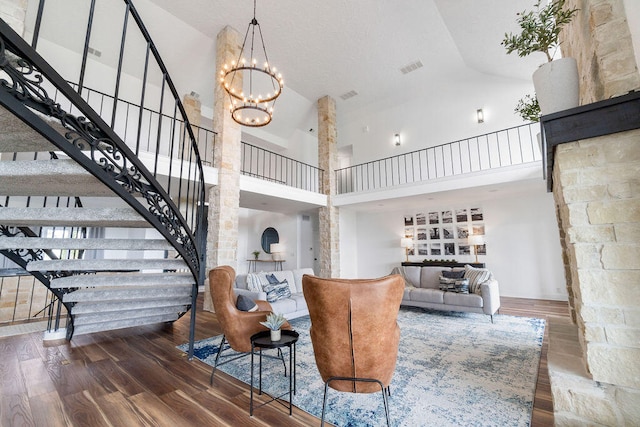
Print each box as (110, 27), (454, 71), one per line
(533, 58), (580, 115)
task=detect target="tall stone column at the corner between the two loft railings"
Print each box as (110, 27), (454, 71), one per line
(318, 96), (340, 277)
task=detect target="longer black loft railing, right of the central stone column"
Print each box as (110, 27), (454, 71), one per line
(335, 123), (542, 194)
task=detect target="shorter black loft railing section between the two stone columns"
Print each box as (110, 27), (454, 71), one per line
(240, 142), (324, 193)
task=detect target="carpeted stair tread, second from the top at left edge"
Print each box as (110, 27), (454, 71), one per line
(0, 159), (114, 197)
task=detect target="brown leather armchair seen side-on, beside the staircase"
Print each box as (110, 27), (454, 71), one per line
(209, 265), (291, 384)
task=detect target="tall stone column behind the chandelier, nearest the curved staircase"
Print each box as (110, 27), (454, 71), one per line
(204, 26), (242, 311)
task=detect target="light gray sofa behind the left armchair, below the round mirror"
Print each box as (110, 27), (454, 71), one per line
(233, 268), (313, 319)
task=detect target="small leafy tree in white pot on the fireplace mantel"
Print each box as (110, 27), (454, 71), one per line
(501, 0), (580, 114)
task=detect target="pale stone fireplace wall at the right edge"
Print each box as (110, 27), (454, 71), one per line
(542, 0), (640, 426)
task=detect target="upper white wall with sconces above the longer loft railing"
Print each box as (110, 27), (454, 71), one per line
(337, 70), (534, 164)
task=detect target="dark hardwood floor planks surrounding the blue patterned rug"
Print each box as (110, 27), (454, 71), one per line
(0, 297), (568, 427)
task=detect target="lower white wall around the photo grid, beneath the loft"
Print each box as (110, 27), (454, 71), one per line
(350, 187), (567, 300)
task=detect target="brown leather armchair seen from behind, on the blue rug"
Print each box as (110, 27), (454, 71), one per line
(302, 274), (404, 425)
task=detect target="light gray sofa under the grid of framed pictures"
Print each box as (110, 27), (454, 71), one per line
(392, 265), (500, 322)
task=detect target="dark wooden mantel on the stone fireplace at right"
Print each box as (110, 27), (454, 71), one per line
(540, 91), (640, 191)
